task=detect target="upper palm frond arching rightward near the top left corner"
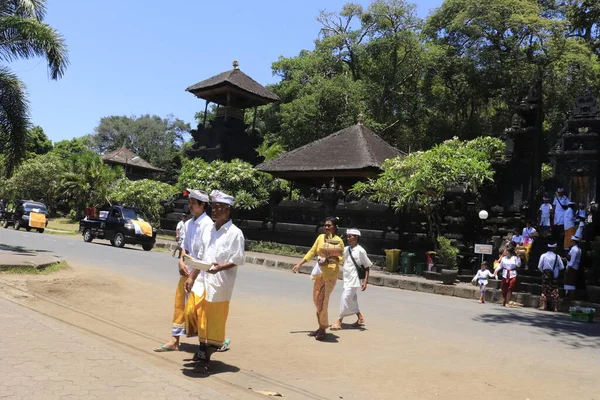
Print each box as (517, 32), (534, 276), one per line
(0, 16), (69, 79)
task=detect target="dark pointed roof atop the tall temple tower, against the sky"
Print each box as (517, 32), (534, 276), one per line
(185, 61), (279, 109)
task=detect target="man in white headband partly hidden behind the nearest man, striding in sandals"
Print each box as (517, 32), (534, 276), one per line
(154, 189), (213, 352)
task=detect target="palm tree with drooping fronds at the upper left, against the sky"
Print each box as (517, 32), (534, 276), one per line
(0, 0), (69, 176)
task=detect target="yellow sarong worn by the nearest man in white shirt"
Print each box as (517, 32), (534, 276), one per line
(185, 292), (229, 347)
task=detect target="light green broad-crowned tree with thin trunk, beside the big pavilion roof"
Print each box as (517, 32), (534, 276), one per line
(351, 137), (505, 246)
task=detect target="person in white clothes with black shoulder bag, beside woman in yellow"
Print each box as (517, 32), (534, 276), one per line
(331, 229), (373, 330)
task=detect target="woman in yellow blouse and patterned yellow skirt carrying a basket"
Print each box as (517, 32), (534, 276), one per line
(292, 217), (344, 340)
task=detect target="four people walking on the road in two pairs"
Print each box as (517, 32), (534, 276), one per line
(153, 189), (372, 374)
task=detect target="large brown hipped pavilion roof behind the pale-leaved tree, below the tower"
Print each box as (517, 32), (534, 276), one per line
(256, 119), (406, 180)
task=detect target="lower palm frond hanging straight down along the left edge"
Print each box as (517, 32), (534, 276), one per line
(0, 67), (29, 176)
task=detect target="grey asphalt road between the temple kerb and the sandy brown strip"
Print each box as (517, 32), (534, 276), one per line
(0, 228), (600, 358)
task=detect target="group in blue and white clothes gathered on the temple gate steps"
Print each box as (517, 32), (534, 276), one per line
(473, 188), (591, 311)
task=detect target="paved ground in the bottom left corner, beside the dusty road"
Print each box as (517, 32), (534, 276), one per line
(0, 299), (231, 400)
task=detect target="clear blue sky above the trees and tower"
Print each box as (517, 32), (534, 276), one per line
(10, 0), (441, 141)
